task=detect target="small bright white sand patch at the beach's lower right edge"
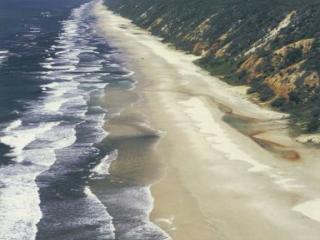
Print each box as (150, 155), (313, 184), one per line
(292, 199), (320, 222)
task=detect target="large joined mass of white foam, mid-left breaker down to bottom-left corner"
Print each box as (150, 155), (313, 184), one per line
(0, 121), (75, 240)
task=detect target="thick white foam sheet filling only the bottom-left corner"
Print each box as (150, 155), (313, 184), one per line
(0, 165), (41, 240)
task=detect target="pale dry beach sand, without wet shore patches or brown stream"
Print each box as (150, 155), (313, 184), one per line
(95, 2), (320, 240)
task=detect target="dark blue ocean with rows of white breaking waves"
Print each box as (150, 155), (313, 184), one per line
(0, 0), (167, 240)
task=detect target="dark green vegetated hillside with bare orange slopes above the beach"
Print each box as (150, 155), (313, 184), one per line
(105, 0), (320, 132)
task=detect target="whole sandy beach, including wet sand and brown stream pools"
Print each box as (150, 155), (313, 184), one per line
(93, 1), (320, 240)
